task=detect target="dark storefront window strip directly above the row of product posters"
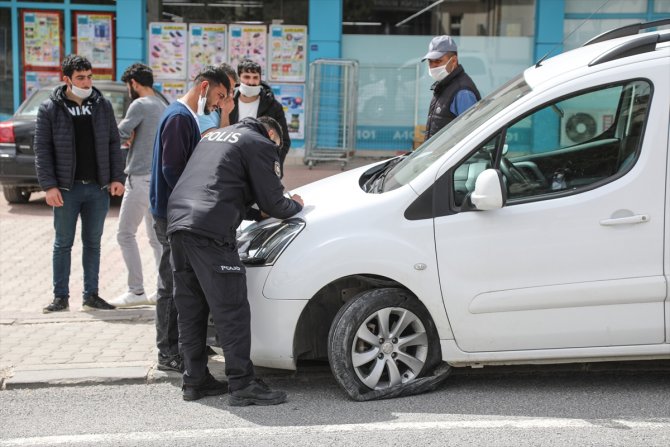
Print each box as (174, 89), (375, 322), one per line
(159, 0), (308, 25)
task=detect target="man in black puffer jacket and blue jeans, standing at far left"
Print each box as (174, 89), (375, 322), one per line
(35, 55), (124, 313)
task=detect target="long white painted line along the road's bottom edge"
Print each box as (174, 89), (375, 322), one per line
(0, 418), (670, 447)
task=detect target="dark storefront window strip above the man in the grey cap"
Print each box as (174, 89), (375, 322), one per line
(342, 0), (535, 37)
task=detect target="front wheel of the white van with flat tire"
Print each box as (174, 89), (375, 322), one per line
(328, 288), (440, 397)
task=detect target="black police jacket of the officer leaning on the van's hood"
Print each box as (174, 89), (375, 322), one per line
(167, 118), (302, 240)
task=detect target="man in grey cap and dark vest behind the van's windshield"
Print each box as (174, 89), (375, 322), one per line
(421, 36), (481, 140)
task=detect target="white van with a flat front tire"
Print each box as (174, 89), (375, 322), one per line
(235, 24), (670, 395)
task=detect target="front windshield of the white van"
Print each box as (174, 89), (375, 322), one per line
(381, 74), (531, 192)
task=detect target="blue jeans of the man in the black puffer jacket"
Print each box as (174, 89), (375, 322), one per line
(53, 182), (109, 298)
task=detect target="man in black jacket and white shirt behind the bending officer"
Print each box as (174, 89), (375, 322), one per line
(230, 59), (291, 171)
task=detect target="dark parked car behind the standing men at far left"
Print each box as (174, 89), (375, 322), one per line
(0, 81), (168, 203)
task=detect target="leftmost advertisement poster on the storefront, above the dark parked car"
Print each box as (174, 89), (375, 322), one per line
(23, 11), (62, 68)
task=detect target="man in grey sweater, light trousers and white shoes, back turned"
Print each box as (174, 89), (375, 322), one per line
(113, 63), (167, 307)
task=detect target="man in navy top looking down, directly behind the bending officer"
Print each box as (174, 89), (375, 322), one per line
(149, 66), (232, 372)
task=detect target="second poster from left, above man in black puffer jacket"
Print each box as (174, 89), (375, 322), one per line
(75, 12), (114, 69)
